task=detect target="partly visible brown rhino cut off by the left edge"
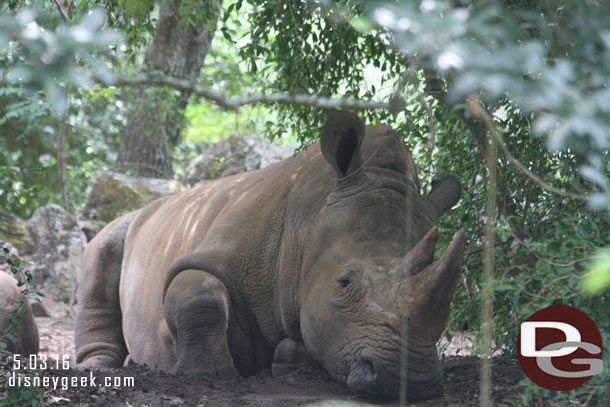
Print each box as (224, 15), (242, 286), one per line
(0, 270), (39, 355)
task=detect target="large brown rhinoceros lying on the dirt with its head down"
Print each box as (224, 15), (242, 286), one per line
(76, 110), (464, 399)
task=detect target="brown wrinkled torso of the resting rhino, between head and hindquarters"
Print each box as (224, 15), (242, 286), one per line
(120, 145), (330, 368)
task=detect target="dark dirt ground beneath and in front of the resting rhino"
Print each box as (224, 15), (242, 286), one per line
(0, 318), (523, 407)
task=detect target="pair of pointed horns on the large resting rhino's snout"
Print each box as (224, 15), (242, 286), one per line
(401, 228), (466, 341)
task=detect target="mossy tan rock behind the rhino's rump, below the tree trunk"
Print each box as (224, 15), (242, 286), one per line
(79, 172), (185, 223)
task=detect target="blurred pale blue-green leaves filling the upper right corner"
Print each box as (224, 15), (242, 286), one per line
(352, 0), (610, 212)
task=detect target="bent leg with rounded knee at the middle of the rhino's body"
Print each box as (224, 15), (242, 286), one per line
(163, 269), (238, 379)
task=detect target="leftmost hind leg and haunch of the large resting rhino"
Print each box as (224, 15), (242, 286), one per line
(75, 212), (137, 367)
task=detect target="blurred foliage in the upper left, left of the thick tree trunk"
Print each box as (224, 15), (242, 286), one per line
(0, 2), (123, 217)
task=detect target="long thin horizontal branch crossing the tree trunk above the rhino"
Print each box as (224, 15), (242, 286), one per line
(94, 74), (394, 110)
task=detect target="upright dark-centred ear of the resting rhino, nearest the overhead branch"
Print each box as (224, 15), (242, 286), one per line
(320, 109), (364, 177)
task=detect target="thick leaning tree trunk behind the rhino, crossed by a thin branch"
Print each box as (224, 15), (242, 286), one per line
(117, 0), (218, 178)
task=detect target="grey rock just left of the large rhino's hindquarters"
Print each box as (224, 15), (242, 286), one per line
(21, 205), (86, 309)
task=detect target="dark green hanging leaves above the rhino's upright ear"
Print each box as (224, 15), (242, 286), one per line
(238, 0), (402, 145)
